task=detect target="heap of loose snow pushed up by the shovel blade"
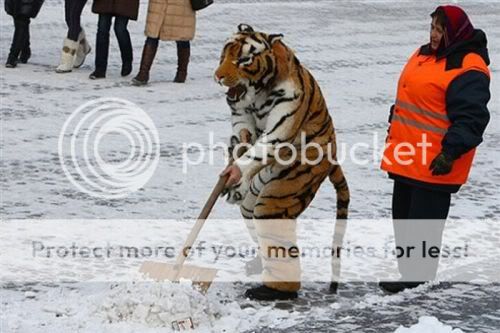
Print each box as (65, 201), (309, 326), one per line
(93, 280), (298, 332)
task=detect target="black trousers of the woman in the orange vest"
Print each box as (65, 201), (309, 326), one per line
(392, 180), (451, 281)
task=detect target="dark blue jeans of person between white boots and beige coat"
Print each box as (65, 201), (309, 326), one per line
(95, 14), (133, 72)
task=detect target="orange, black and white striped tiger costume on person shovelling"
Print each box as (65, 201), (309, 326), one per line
(215, 24), (349, 298)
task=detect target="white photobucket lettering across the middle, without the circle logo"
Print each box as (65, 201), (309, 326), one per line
(182, 132), (433, 174)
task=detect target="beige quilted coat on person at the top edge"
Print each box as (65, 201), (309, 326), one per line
(146, 0), (196, 41)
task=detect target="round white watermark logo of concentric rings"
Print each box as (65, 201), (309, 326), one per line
(58, 98), (160, 199)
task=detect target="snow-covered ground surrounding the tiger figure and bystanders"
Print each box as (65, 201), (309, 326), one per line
(0, 0), (500, 333)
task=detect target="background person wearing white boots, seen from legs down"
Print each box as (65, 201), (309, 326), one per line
(56, 0), (91, 73)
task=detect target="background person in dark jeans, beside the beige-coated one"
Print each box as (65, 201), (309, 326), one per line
(90, 0), (139, 80)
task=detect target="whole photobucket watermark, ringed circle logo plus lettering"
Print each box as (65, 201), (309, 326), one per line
(58, 98), (437, 195)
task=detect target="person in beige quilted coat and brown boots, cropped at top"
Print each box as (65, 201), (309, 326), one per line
(132, 0), (196, 86)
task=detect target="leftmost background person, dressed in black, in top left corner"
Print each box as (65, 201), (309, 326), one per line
(5, 0), (44, 68)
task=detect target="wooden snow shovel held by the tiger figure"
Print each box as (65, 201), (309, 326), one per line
(139, 171), (228, 293)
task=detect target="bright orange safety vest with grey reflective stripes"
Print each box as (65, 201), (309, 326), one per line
(381, 50), (490, 185)
